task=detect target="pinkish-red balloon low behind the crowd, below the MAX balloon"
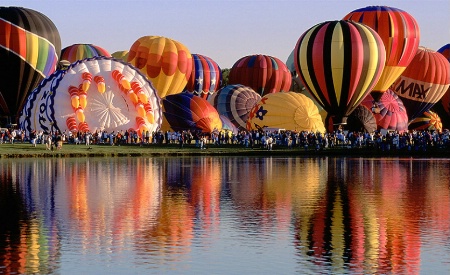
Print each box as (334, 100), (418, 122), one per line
(361, 89), (408, 132)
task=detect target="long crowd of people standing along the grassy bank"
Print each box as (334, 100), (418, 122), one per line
(0, 129), (450, 151)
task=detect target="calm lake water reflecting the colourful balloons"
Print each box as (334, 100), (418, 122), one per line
(0, 157), (450, 274)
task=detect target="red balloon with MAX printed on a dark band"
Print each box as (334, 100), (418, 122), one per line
(392, 47), (450, 120)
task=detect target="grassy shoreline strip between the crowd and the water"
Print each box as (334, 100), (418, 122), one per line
(0, 143), (450, 159)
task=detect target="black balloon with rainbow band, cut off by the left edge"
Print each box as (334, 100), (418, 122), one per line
(0, 7), (61, 123)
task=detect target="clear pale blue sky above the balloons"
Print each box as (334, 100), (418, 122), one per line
(1, 0), (450, 69)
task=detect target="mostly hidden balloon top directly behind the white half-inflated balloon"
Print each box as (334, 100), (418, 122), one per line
(60, 44), (111, 63)
